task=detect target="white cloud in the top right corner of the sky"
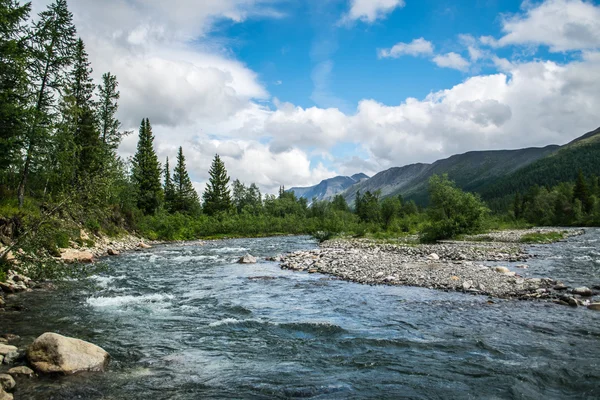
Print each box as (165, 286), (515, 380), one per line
(498, 0), (600, 52)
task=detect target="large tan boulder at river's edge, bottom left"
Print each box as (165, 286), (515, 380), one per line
(27, 333), (110, 374)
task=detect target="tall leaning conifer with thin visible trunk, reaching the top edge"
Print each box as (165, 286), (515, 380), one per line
(17, 0), (76, 207)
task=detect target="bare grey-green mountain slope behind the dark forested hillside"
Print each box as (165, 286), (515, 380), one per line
(344, 146), (559, 205)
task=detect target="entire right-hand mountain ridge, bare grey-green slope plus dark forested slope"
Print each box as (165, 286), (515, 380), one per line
(343, 128), (600, 205)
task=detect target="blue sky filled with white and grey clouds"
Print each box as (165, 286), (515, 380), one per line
(32, 0), (600, 193)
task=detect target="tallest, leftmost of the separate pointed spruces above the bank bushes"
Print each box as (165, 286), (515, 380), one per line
(132, 118), (163, 215)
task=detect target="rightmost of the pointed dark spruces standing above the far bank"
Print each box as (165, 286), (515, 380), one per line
(202, 154), (233, 215)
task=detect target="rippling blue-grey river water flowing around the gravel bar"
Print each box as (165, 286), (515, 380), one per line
(0, 230), (600, 400)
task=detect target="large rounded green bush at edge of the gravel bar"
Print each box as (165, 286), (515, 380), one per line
(421, 175), (489, 242)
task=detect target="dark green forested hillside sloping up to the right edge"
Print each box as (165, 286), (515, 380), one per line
(480, 128), (600, 205)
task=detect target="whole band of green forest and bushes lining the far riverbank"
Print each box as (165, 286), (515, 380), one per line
(0, 0), (600, 280)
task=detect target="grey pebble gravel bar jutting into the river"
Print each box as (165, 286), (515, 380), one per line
(281, 229), (600, 309)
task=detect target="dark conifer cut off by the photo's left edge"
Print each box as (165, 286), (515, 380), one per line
(0, 0), (31, 175)
